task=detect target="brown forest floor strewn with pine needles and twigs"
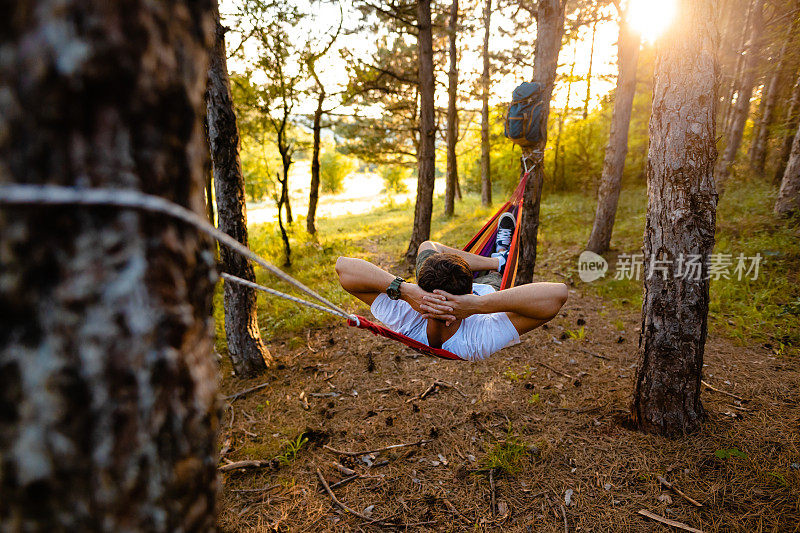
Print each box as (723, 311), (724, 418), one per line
(218, 178), (800, 532)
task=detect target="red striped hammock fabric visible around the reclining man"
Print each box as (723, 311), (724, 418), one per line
(347, 173), (528, 361)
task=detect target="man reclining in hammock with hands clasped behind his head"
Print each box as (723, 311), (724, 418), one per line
(336, 216), (567, 360)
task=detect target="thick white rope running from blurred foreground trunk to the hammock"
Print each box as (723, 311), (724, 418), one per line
(0, 184), (358, 322)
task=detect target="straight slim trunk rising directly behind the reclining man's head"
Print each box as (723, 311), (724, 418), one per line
(405, 0), (436, 267)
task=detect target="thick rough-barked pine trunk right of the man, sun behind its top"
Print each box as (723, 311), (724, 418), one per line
(631, 0), (717, 435)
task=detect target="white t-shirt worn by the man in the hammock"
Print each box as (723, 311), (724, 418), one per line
(370, 283), (519, 361)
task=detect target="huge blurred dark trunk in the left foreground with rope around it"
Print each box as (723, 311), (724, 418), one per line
(0, 0), (219, 531)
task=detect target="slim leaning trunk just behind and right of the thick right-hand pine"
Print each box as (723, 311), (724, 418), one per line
(714, 0), (764, 190)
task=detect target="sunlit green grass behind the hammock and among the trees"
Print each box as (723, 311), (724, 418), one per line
(215, 177), (800, 355)
